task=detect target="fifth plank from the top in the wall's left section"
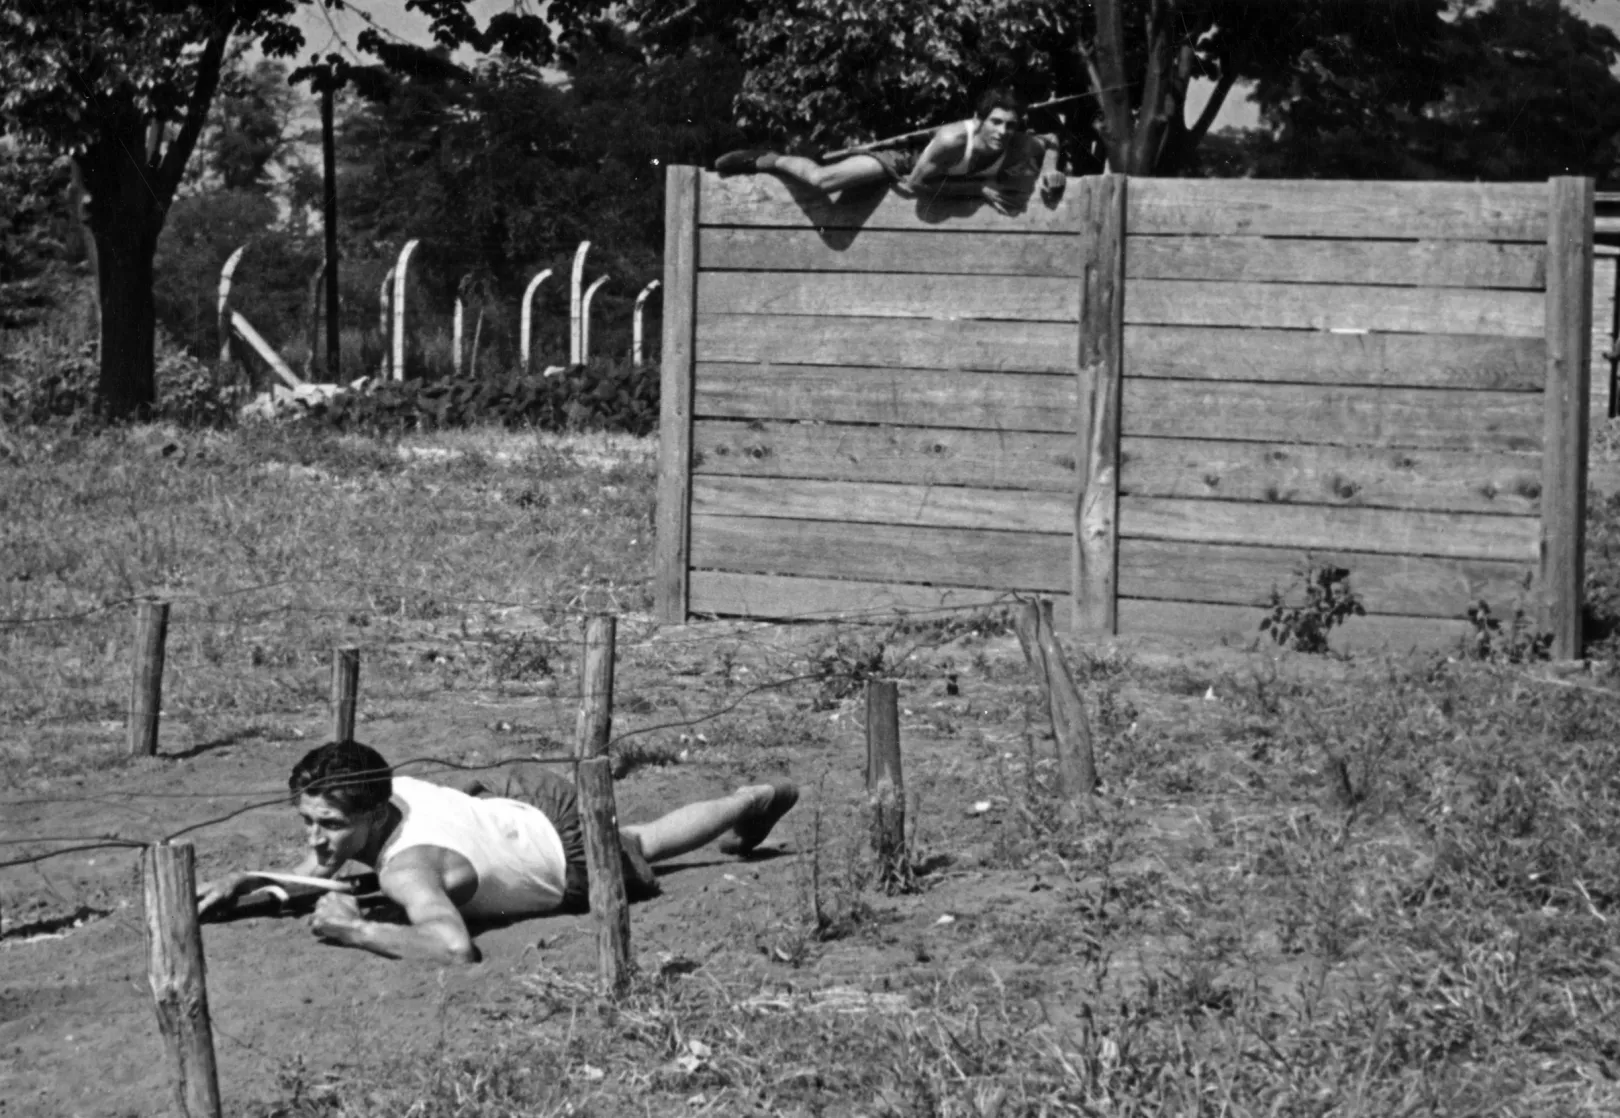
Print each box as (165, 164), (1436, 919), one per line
(692, 363), (1079, 431)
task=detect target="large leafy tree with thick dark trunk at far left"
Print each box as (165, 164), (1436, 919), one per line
(0, 0), (549, 418)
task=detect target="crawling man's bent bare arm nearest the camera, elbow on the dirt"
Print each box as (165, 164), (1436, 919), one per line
(309, 846), (480, 962)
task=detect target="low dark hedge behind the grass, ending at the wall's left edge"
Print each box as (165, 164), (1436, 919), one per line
(308, 361), (658, 434)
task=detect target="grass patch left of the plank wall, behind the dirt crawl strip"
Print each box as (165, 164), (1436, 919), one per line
(0, 426), (653, 779)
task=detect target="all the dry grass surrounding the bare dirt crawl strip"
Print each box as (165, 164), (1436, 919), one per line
(9, 431), (1620, 1118)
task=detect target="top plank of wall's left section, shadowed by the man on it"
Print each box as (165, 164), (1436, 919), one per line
(698, 172), (1079, 230)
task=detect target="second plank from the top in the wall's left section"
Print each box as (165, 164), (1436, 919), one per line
(698, 227), (1079, 277)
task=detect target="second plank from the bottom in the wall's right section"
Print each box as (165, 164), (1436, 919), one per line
(1119, 540), (1533, 617)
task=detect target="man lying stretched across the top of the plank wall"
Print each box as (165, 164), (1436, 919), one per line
(714, 86), (1064, 214)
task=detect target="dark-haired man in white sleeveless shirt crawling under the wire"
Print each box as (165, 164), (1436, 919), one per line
(198, 742), (799, 962)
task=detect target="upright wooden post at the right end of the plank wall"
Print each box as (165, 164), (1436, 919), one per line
(1539, 177), (1594, 659)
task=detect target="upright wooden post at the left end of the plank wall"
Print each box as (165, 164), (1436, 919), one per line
(653, 165), (698, 621)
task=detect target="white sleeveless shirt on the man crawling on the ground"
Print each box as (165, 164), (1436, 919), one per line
(377, 776), (567, 917)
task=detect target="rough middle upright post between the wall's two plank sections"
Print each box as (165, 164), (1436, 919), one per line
(1074, 175), (1126, 635)
